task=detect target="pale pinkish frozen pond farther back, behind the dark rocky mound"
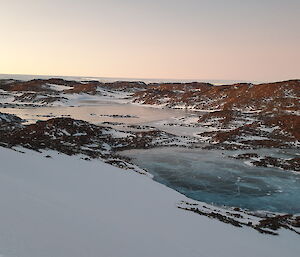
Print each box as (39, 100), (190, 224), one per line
(0, 101), (191, 125)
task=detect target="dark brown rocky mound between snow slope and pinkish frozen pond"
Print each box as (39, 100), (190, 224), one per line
(0, 114), (193, 163)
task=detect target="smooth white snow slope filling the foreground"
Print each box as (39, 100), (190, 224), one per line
(0, 147), (300, 257)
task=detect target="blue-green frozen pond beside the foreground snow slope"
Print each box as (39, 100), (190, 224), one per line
(122, 148), (300, 214)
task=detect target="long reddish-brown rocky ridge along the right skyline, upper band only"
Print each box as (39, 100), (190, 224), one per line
(134, 80), (300, 112)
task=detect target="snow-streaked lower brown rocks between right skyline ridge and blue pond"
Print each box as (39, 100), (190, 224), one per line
(199, 111), (300, 150)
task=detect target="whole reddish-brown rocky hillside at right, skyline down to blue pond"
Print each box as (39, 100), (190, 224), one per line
(134, 80), (300, 150)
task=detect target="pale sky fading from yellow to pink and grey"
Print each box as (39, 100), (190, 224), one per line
(0, 0), (300, 81)
